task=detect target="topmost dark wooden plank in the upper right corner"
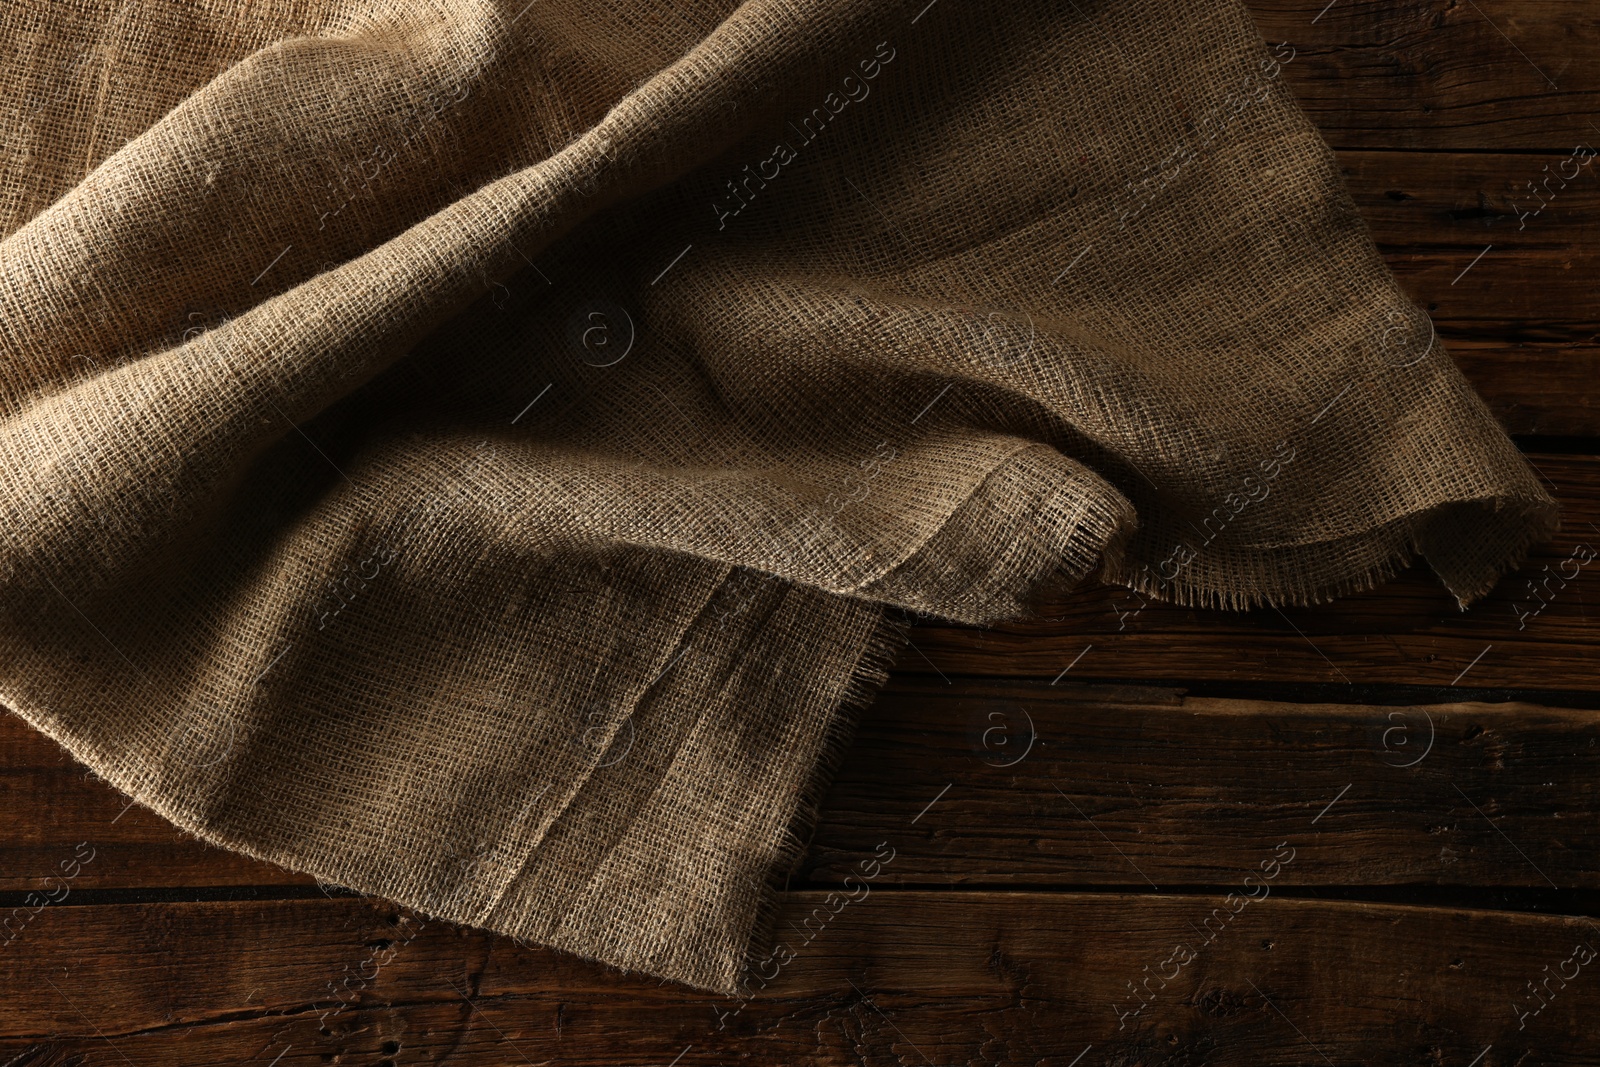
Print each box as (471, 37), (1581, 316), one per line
(1246, 0), (1600, 150)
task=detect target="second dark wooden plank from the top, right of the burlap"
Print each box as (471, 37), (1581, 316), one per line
(1339, 149), (1600, 435)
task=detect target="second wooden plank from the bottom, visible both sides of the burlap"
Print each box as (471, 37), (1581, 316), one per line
(0, 677), (1600, 895)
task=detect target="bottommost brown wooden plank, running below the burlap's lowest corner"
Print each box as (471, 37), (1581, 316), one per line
(0, 895), (1600, 1067)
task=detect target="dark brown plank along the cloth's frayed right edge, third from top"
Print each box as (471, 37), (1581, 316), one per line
(898, 454), (1600, 689)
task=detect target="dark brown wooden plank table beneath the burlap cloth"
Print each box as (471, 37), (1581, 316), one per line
(0, 0), (1600, 1067)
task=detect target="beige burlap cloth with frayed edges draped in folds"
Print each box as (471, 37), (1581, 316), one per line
(0, 0), (1555, 992)
